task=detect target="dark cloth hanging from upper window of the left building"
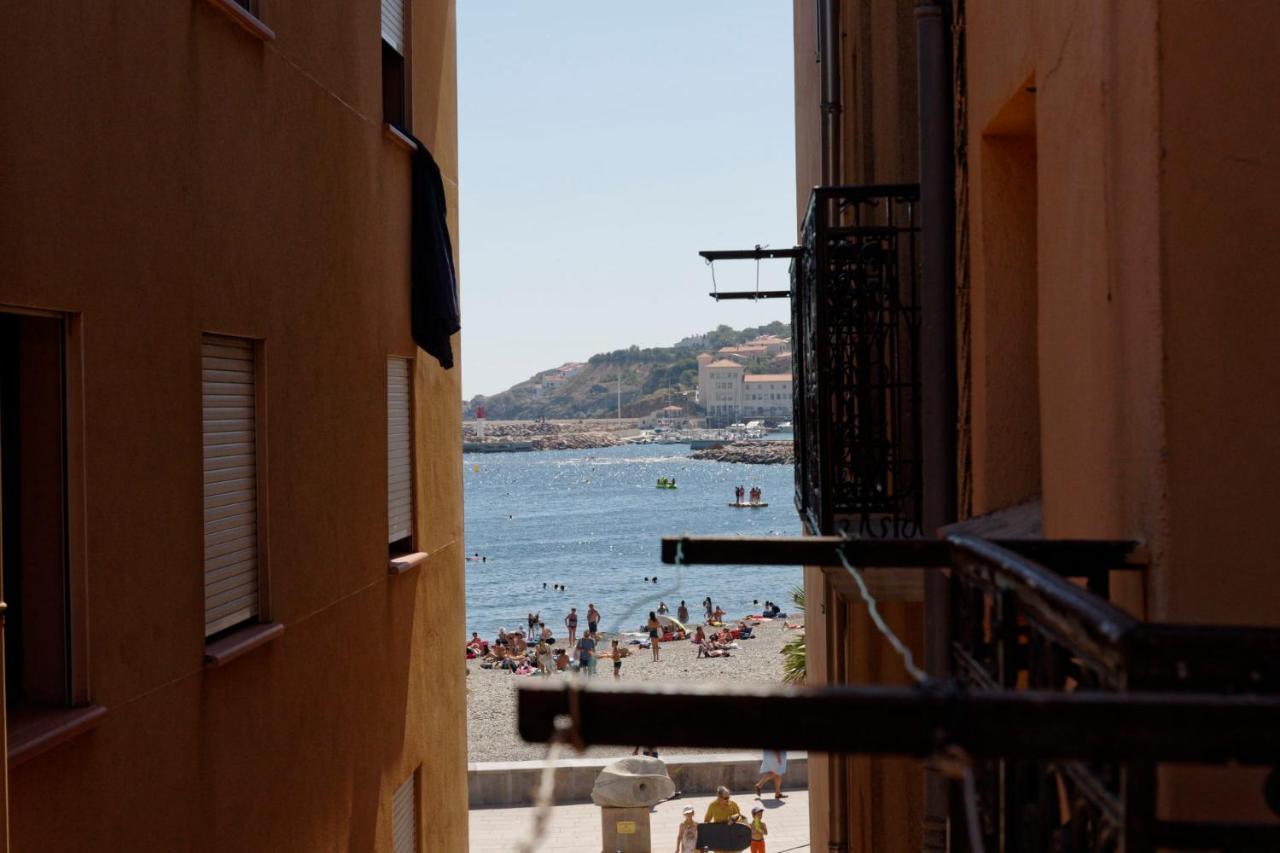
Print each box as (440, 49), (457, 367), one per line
(410, 137), (462, 370)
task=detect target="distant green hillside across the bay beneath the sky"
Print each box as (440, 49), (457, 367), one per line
(465, 323), (791, 420)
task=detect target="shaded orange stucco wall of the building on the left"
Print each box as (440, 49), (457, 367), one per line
(0, 0), (466, 850)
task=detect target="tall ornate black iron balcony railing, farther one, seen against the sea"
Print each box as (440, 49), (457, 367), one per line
(791, 184), (922, 537)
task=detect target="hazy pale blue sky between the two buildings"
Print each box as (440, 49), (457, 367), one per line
(458, 0), (795, 398)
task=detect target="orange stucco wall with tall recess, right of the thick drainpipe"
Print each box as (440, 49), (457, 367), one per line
(966, 0), (1280, 818)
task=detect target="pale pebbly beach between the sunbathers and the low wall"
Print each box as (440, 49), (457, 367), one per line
(467, 619), (803, 761)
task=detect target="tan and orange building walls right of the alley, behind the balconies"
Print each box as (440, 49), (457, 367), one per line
(794, 0), (1280, 853)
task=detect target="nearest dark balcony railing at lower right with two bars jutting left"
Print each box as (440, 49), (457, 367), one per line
(520, 537), (1280, 853)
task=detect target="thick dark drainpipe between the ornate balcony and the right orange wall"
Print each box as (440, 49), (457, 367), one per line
(915, 0), (956, 853)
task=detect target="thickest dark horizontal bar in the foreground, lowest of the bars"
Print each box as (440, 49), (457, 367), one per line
(516, 680), (1280, 765)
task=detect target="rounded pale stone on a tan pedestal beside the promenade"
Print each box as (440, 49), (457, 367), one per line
(591, 756), (676, 853)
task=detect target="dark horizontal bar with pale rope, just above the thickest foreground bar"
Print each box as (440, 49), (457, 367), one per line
(662, 537), (1143, 578)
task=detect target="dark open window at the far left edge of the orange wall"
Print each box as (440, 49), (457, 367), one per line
(0, 314), (70, 710)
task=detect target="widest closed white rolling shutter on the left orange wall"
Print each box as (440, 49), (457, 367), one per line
(201, 334), (257, 637)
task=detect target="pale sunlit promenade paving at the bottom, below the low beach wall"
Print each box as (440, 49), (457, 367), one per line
(470, 790), (809, 853)
